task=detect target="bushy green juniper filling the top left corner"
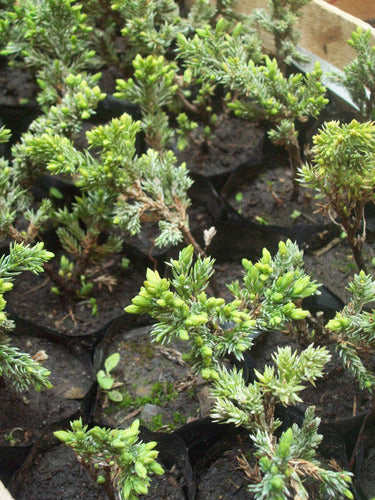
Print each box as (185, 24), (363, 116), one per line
(0, 0), (99, 111)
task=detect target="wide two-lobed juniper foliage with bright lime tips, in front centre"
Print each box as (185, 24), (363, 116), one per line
(125, 241), (317, 379)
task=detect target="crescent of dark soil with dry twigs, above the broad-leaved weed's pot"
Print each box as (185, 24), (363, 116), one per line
(7, 257), (145, 336)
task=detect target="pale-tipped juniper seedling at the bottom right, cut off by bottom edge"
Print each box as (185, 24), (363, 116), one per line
(211, 352), (353, 500)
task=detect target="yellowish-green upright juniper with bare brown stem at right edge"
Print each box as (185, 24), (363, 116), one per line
(298, 120), (375, 270)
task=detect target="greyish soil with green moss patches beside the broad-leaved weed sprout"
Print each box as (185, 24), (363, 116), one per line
(94, 327), (211, 431)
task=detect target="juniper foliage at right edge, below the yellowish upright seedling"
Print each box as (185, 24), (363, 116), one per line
(326, 271), (375, 392)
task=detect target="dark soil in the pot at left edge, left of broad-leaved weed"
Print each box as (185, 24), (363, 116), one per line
(0, 335), (93, 446)
